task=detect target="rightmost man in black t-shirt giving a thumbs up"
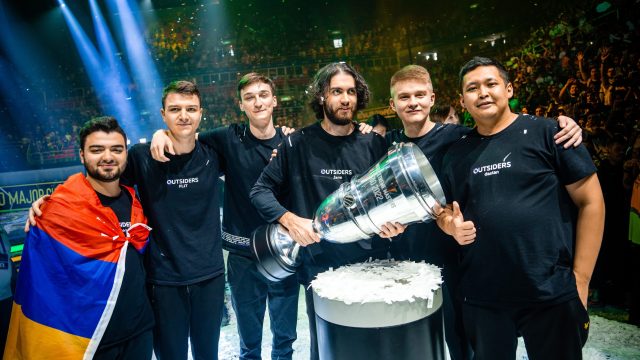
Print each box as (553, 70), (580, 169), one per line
(438, 57), (604, 359)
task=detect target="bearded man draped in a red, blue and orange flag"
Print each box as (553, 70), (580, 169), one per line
(13, 117), (154, 360)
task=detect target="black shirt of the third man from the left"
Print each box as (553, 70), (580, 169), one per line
(198, 124), (284, 256)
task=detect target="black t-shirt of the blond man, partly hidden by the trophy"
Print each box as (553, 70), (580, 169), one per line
(386, 123), (472, 270)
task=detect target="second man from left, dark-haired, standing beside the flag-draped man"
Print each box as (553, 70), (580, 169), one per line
(125, 81), (224, 360)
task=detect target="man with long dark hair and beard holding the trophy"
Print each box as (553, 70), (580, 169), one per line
(251, 63), (404, 359)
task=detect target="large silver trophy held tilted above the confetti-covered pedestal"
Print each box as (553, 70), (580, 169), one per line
(251, 143), (445, 281)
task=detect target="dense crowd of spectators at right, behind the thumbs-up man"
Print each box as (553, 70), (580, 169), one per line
(488, 4), (640, 321)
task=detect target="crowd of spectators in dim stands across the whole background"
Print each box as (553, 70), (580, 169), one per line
(5, 1), (638, 173)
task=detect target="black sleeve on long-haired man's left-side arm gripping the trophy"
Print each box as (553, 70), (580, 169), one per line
(249, 137), (289, 223)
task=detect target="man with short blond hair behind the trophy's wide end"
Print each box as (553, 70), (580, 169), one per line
(387, 65), (582, 360)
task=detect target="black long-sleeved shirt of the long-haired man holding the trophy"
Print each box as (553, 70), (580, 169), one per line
(251, 123), (388, 284)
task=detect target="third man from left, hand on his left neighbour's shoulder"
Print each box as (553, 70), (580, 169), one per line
(151, 72), (300, 359)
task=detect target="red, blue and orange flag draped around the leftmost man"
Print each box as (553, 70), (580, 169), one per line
(4, 174), (150, 359)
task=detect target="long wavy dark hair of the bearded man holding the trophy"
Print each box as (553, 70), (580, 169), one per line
(306, 62), (371, 119)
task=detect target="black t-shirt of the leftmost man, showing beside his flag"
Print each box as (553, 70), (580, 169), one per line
(96, 189), (153, 347)
